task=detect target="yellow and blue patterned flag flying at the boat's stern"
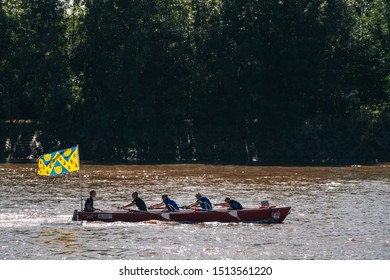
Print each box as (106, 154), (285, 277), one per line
(38, 146), (80, 176)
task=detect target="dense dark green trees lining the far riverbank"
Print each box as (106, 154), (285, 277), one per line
(0, 0), (390, 164)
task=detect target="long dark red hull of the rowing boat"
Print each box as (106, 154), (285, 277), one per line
(73, 207), (291, 224)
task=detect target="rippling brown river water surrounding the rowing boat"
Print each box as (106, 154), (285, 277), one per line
(0, 164), (390, 260)
